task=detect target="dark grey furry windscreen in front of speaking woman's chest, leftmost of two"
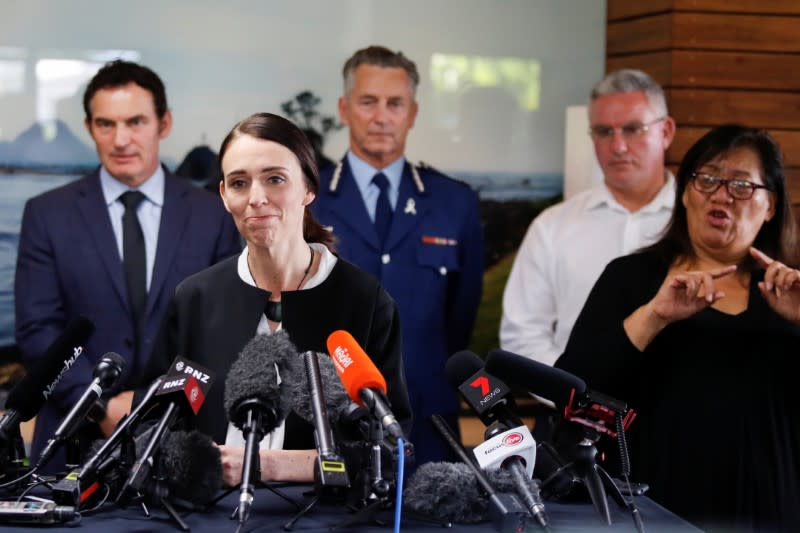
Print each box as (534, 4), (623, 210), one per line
(224, 330), (299, 433)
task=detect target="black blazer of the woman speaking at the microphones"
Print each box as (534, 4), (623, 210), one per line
(141, 257), (411, 449)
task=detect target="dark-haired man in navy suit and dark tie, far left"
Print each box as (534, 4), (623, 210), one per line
(14, 61), (241, 471)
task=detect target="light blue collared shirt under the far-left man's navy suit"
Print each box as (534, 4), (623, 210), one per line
(100, 165), (165, 291)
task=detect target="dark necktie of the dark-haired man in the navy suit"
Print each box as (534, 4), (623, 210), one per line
(119, 191), (147, 340)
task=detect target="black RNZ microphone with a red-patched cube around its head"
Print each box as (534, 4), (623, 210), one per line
(116, 356), (214, 505)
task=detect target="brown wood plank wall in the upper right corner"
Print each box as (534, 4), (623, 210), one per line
(606, 0), (800, 212)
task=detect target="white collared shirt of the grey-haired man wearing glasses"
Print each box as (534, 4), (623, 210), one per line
(500, 173), (675, 365)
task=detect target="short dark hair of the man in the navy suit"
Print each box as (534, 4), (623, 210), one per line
(83, 59), (169, 119)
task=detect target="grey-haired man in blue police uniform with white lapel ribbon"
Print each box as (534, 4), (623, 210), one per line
(311, 46), (483, 463)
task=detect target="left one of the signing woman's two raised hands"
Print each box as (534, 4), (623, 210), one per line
(648, 265), (736, 324)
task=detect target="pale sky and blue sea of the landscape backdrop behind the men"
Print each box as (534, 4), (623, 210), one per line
(0, 0), (605, 346)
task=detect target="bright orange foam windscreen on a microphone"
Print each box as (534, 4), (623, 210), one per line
(328, 330), (386, 405)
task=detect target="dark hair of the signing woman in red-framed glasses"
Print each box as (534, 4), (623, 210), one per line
(645, 124), (798, 272)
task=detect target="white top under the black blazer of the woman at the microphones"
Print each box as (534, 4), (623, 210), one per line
(225, 243), (337, 450)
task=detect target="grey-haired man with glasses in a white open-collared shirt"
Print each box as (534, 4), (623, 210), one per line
(500, 70), (675, 365)
